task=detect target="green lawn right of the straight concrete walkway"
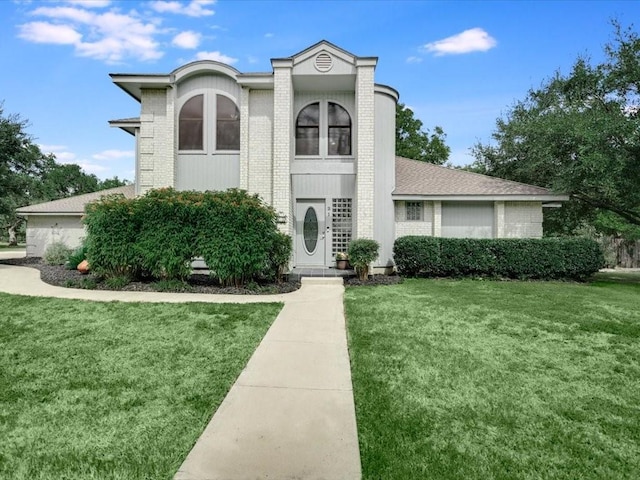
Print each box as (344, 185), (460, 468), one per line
(346, 275), (640, 480)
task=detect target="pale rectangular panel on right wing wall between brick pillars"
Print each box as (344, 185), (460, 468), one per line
(442, 202), (493, 238)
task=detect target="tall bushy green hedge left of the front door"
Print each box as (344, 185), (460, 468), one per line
(84, 189), (291, 286)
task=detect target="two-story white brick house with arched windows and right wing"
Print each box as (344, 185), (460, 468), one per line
(21, 41), (566, 268)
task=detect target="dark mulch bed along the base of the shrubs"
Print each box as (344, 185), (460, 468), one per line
(0, 257), (402, 295)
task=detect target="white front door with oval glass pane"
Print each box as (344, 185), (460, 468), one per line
(295, 200), (327, 267)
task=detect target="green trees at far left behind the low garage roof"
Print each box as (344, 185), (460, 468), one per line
(0, 103), (126, 244)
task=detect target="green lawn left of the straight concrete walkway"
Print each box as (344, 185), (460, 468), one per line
(0, 294), (281, 480)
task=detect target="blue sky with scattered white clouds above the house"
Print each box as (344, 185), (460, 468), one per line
(0, 0), (640, 180)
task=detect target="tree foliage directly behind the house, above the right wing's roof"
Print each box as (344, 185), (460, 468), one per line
(396, 103), (451, 165)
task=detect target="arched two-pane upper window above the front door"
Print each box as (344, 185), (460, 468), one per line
(296, 102), (351, 156)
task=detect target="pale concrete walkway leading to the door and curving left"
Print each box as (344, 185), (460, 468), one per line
(0, 253), (361, 480)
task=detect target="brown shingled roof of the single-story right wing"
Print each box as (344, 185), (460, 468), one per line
(393, 157), (569, 201)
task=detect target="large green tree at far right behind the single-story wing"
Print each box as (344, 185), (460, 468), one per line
(472, 23), (640, 233)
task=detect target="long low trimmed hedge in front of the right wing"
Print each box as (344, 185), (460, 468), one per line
(393, 236), (604, 280)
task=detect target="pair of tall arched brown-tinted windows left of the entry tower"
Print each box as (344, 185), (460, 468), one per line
(178, 94), (240, 152)
